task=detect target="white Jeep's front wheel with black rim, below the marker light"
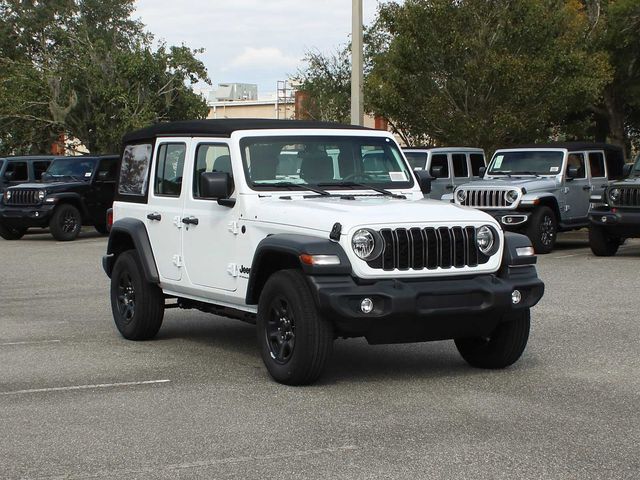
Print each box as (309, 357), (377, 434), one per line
(257, 270), (333, 385)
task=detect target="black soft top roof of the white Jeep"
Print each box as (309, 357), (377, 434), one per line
(122, 118), (371, 143)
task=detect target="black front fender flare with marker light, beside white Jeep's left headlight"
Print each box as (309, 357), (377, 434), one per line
(246, 233), (351, 305)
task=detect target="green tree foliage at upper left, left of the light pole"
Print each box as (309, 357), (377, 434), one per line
(0, 0), (208, 153)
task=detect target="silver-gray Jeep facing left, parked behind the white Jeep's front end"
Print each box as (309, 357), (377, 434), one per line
(443, 142), (624, 253)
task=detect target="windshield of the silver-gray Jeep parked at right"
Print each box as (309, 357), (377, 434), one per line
(488, 150), (564, 175)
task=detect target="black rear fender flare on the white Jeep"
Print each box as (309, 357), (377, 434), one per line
(102, 218), (160, 284)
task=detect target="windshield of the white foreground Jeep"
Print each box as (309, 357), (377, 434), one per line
(240, 136), (413, 190)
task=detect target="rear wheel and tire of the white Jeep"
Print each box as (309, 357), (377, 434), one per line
(111, 250), (164, 340)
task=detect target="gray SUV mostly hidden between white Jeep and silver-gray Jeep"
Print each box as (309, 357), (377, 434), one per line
(402, 147), (486, 200)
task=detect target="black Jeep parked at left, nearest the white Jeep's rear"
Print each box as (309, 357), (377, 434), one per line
(0, 155), (119, 241)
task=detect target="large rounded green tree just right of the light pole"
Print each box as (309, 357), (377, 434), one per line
(368, 0), (609, 149)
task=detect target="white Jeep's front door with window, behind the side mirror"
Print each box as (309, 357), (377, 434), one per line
(182, 139), (241, 291)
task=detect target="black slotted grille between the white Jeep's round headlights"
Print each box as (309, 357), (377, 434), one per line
(367, 227), (488, 270)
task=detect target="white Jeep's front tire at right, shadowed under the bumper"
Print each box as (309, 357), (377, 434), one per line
(455, 308), (531, 369)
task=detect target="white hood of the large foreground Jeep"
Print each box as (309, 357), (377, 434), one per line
(254, 195), (497, 232)
